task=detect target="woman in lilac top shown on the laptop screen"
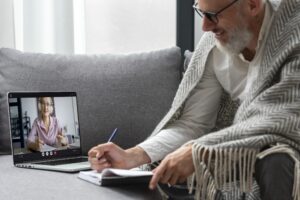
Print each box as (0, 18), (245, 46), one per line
(27, 97), (68, 151)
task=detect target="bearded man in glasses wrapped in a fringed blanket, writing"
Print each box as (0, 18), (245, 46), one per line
(89, 0), (300, 200)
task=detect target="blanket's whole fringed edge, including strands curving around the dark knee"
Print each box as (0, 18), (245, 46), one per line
(188, 144), (300, 200)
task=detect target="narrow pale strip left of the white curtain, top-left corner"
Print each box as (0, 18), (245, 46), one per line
(0, 0), (15, 48)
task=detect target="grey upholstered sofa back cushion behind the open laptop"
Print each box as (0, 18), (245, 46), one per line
(0, 47), (181, 153)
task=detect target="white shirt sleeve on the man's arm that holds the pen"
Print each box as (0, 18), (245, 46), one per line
(138, 59), (222, 162)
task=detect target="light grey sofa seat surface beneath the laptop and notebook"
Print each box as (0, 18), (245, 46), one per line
(0, 155), (161, 200)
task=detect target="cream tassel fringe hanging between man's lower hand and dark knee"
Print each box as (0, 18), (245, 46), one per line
(189, 144), (258, 200)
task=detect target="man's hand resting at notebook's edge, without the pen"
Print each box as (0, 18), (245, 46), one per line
(149, 145), (195, 189)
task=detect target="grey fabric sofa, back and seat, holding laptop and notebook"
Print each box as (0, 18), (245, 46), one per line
(0, 47), (181, 200)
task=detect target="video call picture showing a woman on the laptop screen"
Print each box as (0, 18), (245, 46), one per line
(9, 97), (80, 154)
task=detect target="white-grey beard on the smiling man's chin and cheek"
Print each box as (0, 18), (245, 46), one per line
(216, 25), (252, 55)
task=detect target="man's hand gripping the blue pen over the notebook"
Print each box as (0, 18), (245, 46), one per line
(88, 142), (150, 171)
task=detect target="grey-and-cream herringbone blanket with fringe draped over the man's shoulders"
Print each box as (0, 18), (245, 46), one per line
(152, 0), (300, 200)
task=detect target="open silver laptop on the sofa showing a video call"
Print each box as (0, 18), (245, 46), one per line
(7, 92), (90, 172)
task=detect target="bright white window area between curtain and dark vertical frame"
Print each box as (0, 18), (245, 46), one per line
(85, 0), (176, 53)
